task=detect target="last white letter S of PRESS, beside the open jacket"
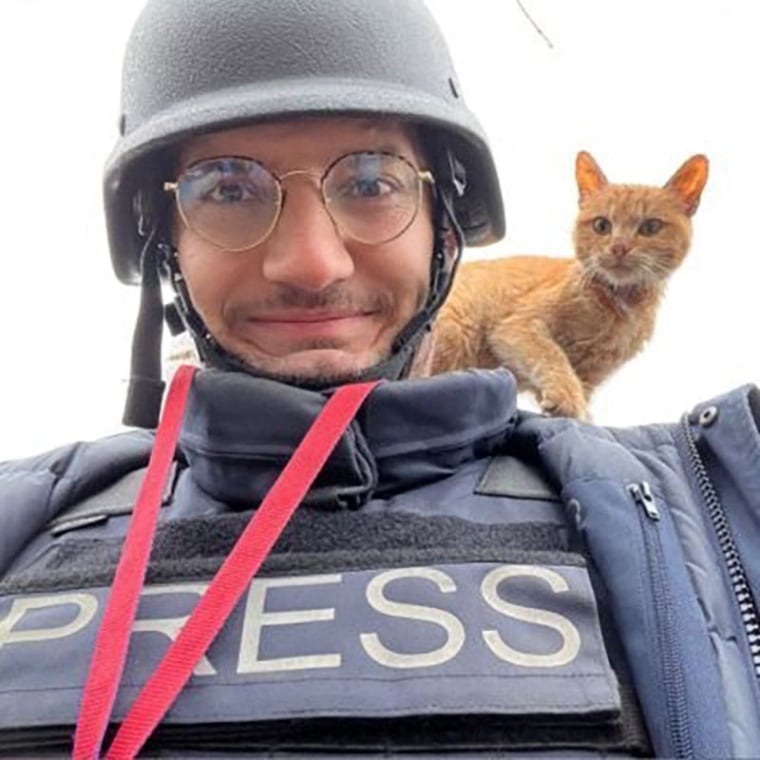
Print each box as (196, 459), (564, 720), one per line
(480, 565), (581, 668)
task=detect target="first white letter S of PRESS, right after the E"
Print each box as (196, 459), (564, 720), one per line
(359, 567), (465, 668)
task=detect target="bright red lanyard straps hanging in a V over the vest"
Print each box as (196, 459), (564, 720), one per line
(73, 367), (377, 760)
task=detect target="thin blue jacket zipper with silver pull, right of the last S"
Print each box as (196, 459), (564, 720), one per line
(628, 480), (694, 758)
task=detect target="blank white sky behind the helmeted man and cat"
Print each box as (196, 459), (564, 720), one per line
(0, 0), (760, 459)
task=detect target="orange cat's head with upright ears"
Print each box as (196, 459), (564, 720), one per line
(573, 151), (708, 288)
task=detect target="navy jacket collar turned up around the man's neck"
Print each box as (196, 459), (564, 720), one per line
(179, 370), (516, 509)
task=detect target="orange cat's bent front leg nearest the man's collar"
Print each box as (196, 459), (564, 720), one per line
(487, 317), (589, 420)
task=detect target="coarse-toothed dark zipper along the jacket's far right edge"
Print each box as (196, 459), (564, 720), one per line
(681, 415), (760, 678)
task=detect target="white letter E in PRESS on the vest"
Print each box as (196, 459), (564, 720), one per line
(237, 575), (343, 673)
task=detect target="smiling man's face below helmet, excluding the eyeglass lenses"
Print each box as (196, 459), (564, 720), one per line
(176, 118), (433, 380)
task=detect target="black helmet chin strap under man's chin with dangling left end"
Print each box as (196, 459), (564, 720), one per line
(123, 171), (464, 428)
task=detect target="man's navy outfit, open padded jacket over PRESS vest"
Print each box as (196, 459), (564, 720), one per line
(0, 371), (760, 758)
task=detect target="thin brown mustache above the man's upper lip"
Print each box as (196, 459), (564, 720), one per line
(228, 283), (393, 321)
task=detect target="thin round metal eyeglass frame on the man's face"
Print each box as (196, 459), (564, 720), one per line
(162, 150), (435, 253)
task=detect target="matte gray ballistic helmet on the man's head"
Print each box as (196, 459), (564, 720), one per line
(104, 0), (504, 283)
